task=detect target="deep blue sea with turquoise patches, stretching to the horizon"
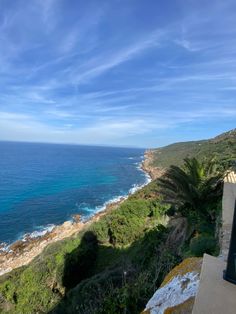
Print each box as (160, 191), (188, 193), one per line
(0, 142), (147, 243)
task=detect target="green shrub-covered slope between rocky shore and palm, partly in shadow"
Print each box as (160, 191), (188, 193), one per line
(0, 196), (178, 313)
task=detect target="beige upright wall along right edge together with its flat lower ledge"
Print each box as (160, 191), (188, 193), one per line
(193, 171), (236, 314)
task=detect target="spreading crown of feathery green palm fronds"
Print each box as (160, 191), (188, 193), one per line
(158, 158), (223, 218)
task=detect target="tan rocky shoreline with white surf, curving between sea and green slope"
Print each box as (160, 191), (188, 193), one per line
(0, 151), (157, 276)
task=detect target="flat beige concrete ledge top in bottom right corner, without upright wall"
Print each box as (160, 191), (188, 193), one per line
(192, 254), (236, 314)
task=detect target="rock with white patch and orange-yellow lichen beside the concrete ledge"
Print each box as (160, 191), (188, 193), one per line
(143, 257), (202, 314)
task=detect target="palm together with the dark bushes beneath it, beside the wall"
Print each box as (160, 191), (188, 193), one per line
(158, 158), (224, 256)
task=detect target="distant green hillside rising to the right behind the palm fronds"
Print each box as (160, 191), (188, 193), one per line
(152, 129), (236, 168)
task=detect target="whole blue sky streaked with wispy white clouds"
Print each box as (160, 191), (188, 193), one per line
(0, 0), (236, 147)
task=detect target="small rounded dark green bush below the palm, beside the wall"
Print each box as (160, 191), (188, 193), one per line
(190, 235), (218, 257)
